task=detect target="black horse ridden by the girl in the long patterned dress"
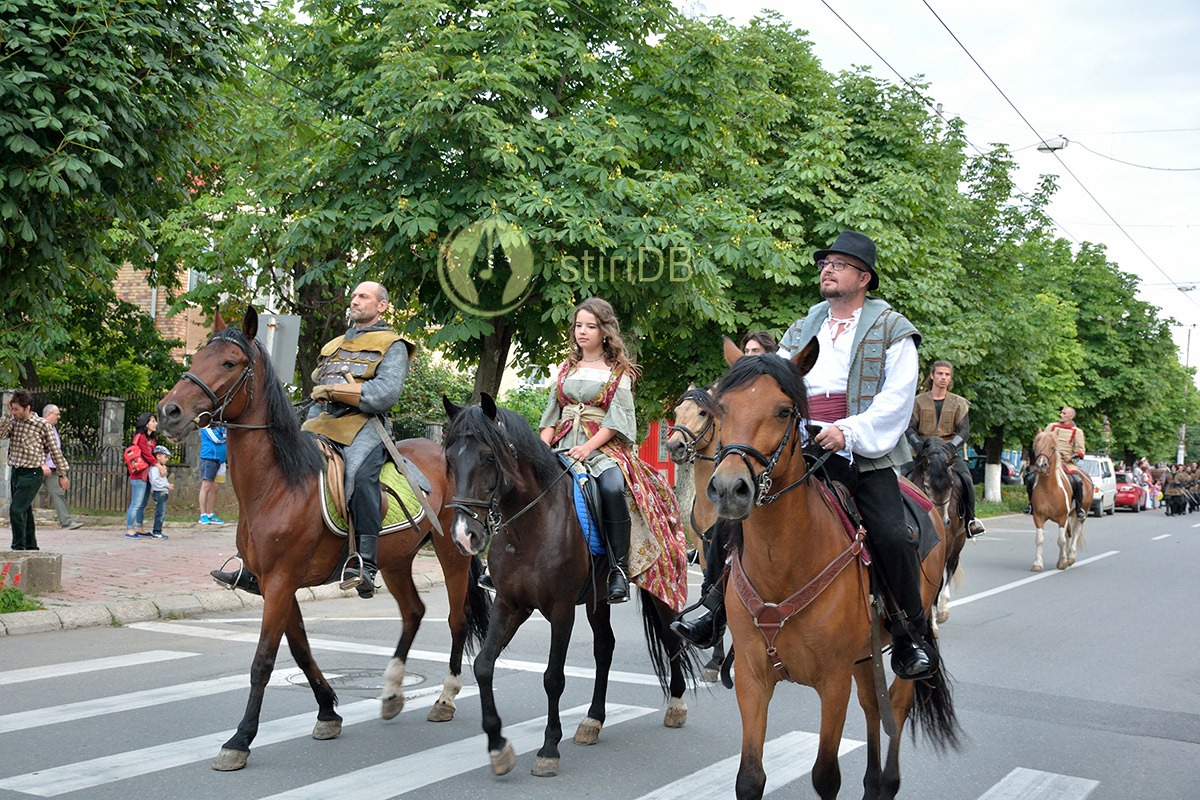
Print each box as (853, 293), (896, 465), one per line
(444, 393), (695, 777)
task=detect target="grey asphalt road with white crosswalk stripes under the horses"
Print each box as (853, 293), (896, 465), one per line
(0, 512), (1200, 800)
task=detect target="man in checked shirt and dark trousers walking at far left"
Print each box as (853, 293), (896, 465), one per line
(0, 389), (71, 551)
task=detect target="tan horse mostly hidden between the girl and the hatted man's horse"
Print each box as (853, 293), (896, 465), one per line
(667, 386), (725, 684)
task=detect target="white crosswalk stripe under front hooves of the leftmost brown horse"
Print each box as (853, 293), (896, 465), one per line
(0, 686), (479, 798)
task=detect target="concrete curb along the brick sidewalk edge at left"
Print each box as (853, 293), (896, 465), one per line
(0, 573), (444, 636)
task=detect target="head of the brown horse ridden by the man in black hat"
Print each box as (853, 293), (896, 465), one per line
(706, 338), (820, 519)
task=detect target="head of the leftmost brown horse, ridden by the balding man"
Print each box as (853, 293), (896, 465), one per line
(158, 306), (264, 440)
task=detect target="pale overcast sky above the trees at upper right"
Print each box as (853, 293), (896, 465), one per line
(679, 0), (1200, 388)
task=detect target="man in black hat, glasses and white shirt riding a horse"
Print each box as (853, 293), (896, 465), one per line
(671, 230), (938, 680)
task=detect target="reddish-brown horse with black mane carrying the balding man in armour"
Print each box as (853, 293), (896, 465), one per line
(158, 308), (488, 771)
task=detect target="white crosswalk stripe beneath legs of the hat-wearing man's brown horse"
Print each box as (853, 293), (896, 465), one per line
(638, 730), (866, 800)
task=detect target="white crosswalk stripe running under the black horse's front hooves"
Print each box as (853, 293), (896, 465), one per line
(263, 704), (655, 800)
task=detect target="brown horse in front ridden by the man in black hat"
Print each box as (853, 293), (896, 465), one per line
(708, 339), (959, 799)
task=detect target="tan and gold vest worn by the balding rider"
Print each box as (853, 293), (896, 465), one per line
(301, 331), (407, 445)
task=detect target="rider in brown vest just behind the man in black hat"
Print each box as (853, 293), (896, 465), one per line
(907, 361), (986, 539)
